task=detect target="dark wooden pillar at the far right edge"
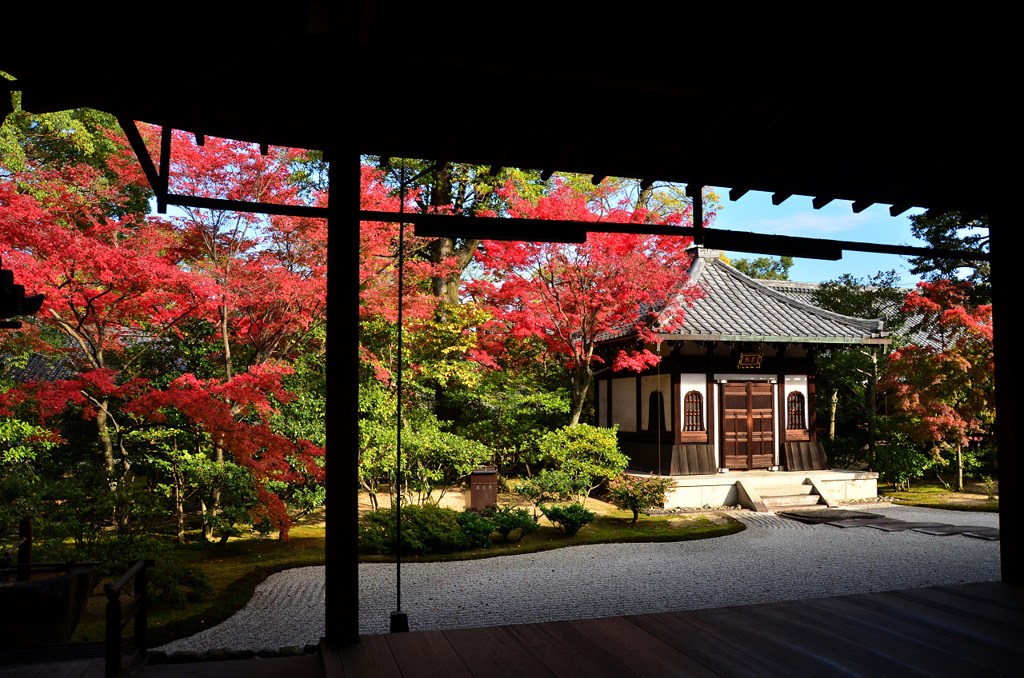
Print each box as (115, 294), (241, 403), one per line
(988, 205), (1024, 585)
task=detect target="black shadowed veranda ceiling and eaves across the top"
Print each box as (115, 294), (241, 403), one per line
(0, 0), (1012, 220)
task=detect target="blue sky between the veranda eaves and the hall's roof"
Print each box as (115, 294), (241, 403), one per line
(715, 188), (924, 287)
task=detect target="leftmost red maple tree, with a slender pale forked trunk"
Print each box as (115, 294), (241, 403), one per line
(0, 161), (208, 471)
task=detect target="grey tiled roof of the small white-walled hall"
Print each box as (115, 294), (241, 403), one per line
(638, 249), (889, 344)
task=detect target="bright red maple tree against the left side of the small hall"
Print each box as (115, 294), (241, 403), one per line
(464, 184), (699, 425)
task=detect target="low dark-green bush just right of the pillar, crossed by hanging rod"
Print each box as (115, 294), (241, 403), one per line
(359, 504), (469, 555)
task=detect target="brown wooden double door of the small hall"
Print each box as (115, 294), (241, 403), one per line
(722, 381), (775, 470)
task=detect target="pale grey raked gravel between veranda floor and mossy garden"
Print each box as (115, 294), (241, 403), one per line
(159, 506), (999, 651)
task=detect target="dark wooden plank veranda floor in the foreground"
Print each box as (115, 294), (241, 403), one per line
(9, 583), (1024, 678)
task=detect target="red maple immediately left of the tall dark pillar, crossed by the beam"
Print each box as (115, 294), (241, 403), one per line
(123, 126), (327, 379)
